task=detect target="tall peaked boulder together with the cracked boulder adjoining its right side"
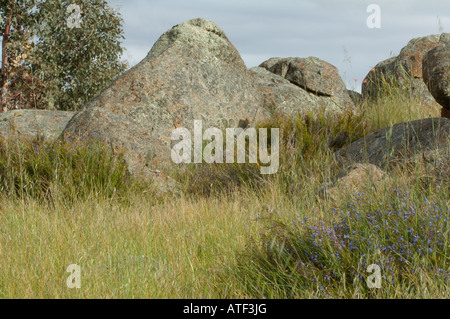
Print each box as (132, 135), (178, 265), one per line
(59, 19), (362, 181)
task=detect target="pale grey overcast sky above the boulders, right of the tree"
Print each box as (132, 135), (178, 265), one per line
(109, 0), (450, 91)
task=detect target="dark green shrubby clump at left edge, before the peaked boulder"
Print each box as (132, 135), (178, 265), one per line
(0, 138), (151, 201)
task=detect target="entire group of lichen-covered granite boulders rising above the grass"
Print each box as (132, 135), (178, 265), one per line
(0, 18), (450, 195)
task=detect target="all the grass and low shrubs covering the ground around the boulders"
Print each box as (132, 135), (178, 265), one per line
(0, 86), (450, 298)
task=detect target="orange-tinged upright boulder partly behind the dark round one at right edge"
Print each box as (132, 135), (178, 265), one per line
(362, 35), (440, 106)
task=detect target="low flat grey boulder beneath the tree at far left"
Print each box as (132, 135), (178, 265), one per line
(0, 110), (75, 140)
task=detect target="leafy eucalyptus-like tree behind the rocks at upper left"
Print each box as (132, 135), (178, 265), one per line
(0, 0), (126, 110)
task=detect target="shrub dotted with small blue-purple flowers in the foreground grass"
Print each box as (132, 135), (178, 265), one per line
(243, 190), (450, 298)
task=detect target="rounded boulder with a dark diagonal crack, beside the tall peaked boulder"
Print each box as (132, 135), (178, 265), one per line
(251, 57), (355, 114)
